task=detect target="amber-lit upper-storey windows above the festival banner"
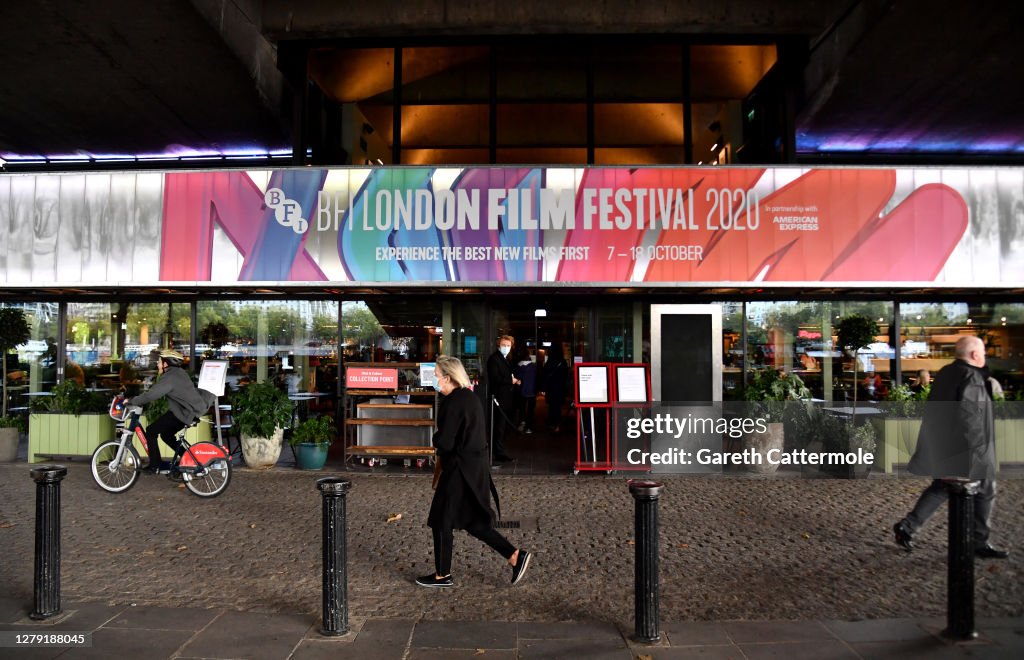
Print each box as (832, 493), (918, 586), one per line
(308, 37), (777, 165)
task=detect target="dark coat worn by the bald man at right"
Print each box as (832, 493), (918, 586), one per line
(907, 360), (996, 480)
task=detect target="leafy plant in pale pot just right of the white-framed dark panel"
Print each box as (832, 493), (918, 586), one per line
(743, 368), (811, 474)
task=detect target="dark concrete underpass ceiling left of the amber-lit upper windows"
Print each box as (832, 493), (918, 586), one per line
(0, 0), (291, 160)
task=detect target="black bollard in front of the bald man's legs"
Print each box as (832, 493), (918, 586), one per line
(942, 479), (981, 640)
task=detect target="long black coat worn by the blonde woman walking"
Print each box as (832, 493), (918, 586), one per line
(427, 388), (501, 529)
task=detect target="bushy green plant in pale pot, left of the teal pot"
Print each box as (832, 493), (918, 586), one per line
(234, 381), (292, 470)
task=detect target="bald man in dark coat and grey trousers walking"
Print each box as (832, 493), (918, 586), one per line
(893, 337), (1008, 559)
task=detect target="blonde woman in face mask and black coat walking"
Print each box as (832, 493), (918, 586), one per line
(416, 356), (531, 586)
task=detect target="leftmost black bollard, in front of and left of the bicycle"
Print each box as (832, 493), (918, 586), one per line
(29, 466), (68, 620)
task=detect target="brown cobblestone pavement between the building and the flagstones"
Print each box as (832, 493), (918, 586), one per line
(0, 461), (1024, 629)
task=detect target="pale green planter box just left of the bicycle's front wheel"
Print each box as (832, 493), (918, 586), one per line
(29, 412), (114, 463)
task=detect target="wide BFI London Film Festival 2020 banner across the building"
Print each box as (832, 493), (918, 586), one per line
(0, 167), (1024, 288)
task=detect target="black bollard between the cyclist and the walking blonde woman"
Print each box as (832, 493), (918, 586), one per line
(316, 477), (352, 636)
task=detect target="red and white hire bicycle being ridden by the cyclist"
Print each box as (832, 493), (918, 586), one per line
(91, 395), (231, 497)
